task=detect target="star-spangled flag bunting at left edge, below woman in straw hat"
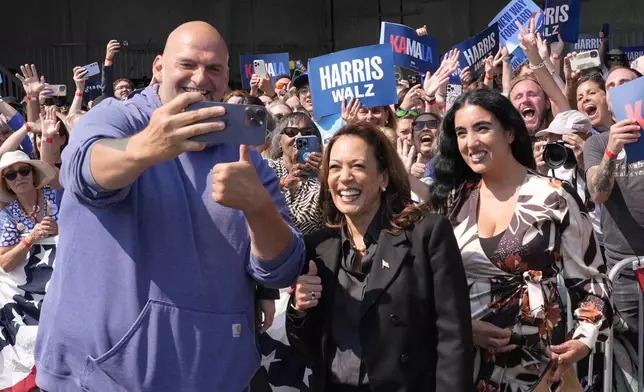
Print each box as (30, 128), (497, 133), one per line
(0, 237), (58, 392)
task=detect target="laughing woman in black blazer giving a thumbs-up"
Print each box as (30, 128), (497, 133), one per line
(286, 122), (474, 392)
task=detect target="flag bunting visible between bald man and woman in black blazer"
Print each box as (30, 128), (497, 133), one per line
(253, 289), (311, 392)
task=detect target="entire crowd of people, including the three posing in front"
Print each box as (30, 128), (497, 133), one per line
(0, 10), (644, 392)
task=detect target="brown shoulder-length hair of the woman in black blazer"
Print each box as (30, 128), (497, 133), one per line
(320, 121), (423, 234)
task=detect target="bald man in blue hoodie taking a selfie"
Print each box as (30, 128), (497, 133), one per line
(36, 22), (304, 392)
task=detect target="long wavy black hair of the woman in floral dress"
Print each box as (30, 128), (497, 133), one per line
(429, 89), (536, 214)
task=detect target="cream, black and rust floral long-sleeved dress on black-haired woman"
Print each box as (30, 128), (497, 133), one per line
(450, 172), (613, 392)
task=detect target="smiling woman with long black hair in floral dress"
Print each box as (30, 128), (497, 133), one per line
(430, 90), (612, 392)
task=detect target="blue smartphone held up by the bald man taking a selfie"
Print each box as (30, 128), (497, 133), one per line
(186, 101), (267, 146)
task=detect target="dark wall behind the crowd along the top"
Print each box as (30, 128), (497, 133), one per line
(0, 0), (644, 95)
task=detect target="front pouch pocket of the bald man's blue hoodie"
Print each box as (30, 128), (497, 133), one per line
(81, 300), (259, 392)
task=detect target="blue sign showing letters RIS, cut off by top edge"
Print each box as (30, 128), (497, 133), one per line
(541, 0), (581, 44)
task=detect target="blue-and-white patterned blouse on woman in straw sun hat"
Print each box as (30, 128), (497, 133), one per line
(0, 187), (58, 246)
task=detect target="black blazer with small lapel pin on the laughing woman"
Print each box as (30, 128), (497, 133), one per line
(286, 214), (474, 392)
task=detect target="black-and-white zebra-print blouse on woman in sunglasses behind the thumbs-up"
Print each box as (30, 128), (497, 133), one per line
(267, 158), (323, 234)
